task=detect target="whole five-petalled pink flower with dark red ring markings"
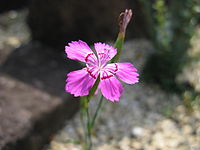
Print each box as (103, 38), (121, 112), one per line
(65, 40), (139, 102)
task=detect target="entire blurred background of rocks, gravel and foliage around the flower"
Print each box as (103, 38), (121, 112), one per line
(0, 0), (200, 150)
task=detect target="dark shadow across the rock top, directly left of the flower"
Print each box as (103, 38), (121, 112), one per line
(1, 42), (80, 97)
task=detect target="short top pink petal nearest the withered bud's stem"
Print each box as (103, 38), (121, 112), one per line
(94, 42), (117, 65)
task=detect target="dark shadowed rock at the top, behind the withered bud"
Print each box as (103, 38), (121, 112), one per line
(28, 0), (145, 45)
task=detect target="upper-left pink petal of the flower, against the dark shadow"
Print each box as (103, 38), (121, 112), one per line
(65, 40), (97, 64)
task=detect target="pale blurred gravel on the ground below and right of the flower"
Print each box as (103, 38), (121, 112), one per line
(45, 39), (200, 150)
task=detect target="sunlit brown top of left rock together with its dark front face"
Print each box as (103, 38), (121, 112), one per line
(0, 75), (78, 150)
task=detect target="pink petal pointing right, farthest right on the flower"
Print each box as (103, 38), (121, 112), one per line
(105, 63), (139, 84)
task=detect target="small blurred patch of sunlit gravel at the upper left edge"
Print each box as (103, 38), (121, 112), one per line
(0, 10), (30, 64)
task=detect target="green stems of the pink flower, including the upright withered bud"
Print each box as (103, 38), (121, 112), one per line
(81, 9), (132, 150)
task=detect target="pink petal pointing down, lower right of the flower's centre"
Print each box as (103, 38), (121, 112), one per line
(99, 71), (123, 102)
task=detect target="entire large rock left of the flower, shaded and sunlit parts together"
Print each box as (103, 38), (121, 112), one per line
(0, 42), (79, 150)
